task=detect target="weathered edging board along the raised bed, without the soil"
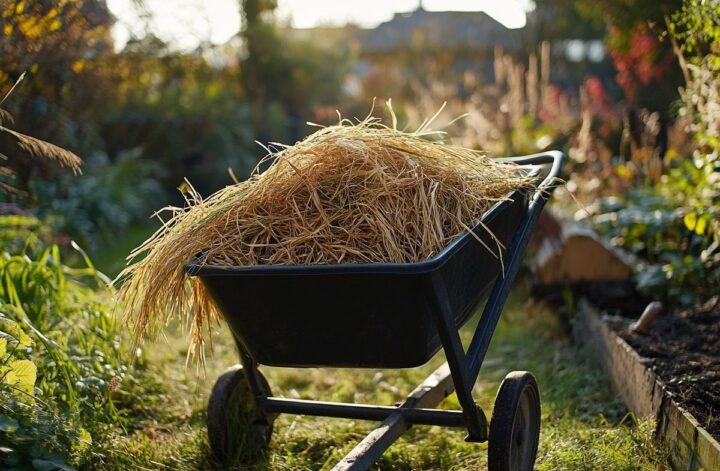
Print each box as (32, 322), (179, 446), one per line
(573, 299), (720, 471)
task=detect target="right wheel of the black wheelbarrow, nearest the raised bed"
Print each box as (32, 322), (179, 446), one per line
(488, 371), (540, 471)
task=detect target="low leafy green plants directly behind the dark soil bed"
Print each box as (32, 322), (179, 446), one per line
(594, 175), (720, 305)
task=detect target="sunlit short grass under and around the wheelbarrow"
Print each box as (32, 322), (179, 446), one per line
(93, 282), (665, 470)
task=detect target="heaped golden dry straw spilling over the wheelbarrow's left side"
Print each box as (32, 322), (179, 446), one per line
(119, 111), (530, 361)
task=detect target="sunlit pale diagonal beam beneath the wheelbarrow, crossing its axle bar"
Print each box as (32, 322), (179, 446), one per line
(333, 363), (454, 471)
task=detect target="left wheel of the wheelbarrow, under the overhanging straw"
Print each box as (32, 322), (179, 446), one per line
(207, 365), (276, 464)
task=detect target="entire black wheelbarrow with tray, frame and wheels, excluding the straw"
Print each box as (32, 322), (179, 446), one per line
(187, 151), (563, 470)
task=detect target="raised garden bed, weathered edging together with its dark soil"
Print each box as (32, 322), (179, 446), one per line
(574, 300), (720, 470)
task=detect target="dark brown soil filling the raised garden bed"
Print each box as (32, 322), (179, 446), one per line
(611, 296), (720, 440)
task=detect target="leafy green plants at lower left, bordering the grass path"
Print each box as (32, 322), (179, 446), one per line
(0, 220), (130, 470)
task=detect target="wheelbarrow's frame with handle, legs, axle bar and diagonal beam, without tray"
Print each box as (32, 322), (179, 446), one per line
(222, 151), (563, 471)
